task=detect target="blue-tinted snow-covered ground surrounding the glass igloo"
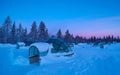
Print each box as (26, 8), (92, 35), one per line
(0, 43), (120, 75)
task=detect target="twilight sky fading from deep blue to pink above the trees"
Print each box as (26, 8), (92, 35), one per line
(0, 0), (120, 36)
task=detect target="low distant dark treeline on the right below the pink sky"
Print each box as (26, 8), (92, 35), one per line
(75, 35), (120, 44)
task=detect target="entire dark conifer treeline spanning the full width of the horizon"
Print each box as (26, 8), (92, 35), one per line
(0, 16), (120, 45)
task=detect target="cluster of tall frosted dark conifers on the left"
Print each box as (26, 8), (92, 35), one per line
(0, 16), (49, 44)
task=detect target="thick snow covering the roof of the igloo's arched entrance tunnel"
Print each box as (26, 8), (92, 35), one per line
(30, 42), (52, 52)
